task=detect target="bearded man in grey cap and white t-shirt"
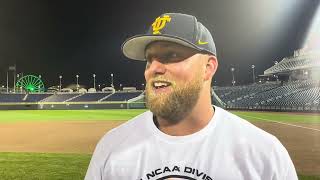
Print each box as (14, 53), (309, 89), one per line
(85, 13), (298, 180)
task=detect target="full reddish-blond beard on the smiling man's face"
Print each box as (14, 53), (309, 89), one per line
(146, 77), (203, 124)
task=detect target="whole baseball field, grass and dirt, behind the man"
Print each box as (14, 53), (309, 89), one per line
(0, 110), (320, 180)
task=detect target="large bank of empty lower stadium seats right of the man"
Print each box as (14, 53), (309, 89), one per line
(215, 81), (320, 110)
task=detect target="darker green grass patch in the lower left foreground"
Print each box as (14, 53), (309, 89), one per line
(0, 153), (91, 180)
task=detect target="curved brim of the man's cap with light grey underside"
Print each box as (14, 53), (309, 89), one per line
(122, 35), (201, 61)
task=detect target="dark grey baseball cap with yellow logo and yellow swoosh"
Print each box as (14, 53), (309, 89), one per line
(122, 13), (217, 61)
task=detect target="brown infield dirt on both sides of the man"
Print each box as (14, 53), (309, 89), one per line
(0, 121), (320, 175)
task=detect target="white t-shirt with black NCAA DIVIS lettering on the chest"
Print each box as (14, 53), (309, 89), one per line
(85, 107), (298, 180)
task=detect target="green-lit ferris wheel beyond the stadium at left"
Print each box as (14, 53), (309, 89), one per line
(16, 75), (44, 92)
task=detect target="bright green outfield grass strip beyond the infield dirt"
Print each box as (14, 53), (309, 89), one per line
(0, 109), (320, 123)
